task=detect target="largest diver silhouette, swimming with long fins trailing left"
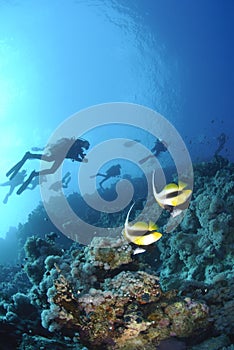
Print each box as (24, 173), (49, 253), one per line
(6, 137), (90, 194)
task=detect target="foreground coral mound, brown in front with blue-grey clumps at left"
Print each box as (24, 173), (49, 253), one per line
(2, 236), (209, 350)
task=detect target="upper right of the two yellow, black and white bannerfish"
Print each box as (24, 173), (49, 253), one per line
(152, 173), (192, 217)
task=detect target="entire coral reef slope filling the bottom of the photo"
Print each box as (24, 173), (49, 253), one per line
(0, 156), (234, 350)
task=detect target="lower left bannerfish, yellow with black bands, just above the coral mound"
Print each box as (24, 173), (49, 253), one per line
(123, 204), (162, 254)
